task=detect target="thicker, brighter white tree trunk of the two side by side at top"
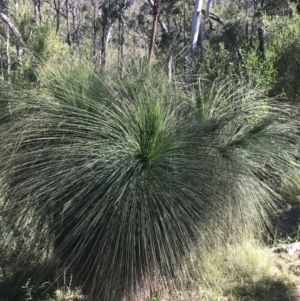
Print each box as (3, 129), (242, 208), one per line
(186, 0), (203, 76)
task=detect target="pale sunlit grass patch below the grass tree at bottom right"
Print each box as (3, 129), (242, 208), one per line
(194, 238), (296, 301)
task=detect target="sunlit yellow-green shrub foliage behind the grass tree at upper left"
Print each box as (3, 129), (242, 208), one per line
(11, 3), (68, 89)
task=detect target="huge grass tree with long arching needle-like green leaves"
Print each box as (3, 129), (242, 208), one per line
(0, 68), (298, 300)
